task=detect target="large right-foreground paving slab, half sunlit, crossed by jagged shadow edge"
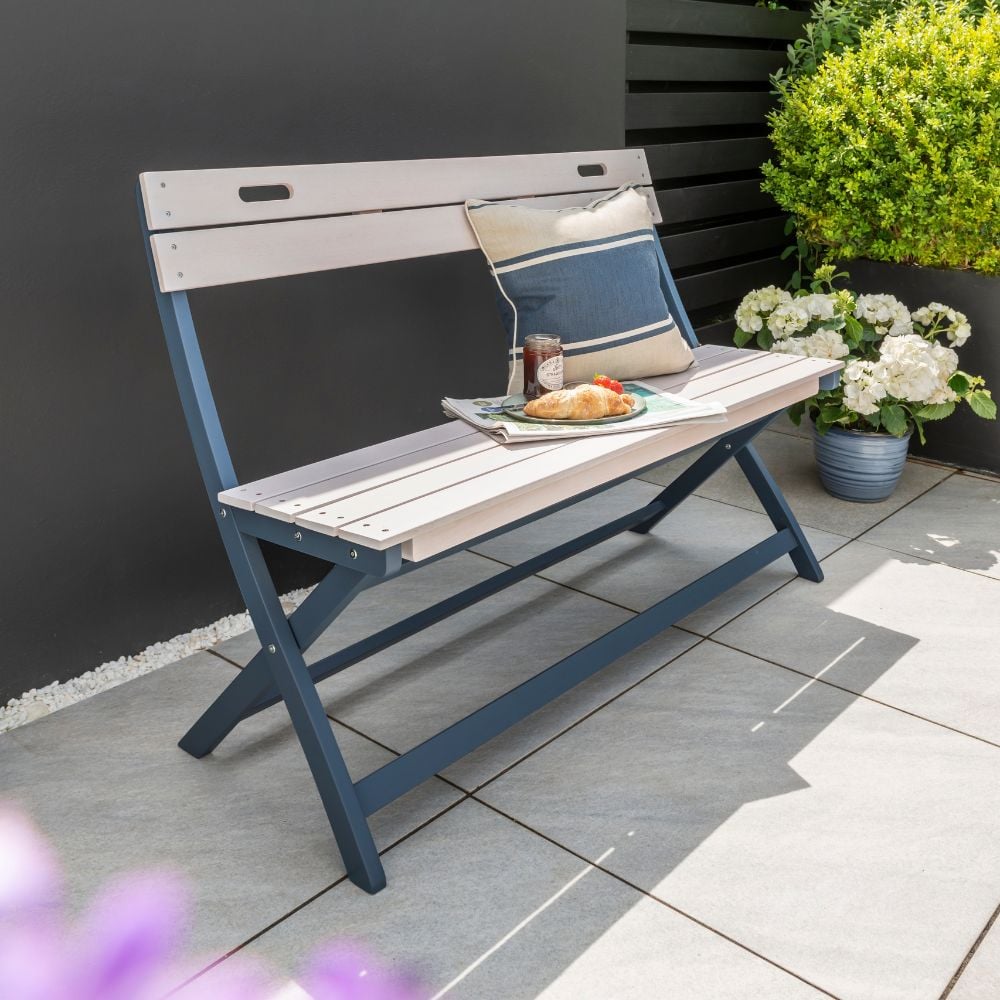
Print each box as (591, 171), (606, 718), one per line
(478, 642), (1000, 1000)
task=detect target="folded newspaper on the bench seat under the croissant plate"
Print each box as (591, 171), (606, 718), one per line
(441, 382), (726, 443)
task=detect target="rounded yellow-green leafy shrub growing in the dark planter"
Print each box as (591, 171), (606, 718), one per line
(764, 2), (1000, 274)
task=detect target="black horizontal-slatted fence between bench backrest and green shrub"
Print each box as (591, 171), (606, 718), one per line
(625, 0), (806, 343)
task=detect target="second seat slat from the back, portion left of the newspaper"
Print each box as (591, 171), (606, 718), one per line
(254, 425), (500, 521)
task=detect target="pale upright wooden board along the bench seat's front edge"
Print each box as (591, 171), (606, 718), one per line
(400, 382), (817, 561)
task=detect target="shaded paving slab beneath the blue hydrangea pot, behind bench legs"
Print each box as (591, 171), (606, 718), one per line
(643, 431), (953, 538)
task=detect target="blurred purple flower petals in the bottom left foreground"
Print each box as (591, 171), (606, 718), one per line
(0, 805), (418, 1000)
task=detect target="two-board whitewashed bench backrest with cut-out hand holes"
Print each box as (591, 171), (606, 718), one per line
(139, 149), (660, 292)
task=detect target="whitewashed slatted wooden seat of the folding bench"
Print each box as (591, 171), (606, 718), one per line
(219, 346), (839, 561)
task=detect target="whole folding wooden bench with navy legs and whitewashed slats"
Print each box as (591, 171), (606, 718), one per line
(138, 149), (841, 893)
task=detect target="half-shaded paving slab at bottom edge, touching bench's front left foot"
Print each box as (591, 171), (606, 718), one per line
(189, 802), (822, 1000)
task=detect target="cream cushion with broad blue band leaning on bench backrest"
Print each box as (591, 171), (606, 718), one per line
(465, 187), (694, 388)
